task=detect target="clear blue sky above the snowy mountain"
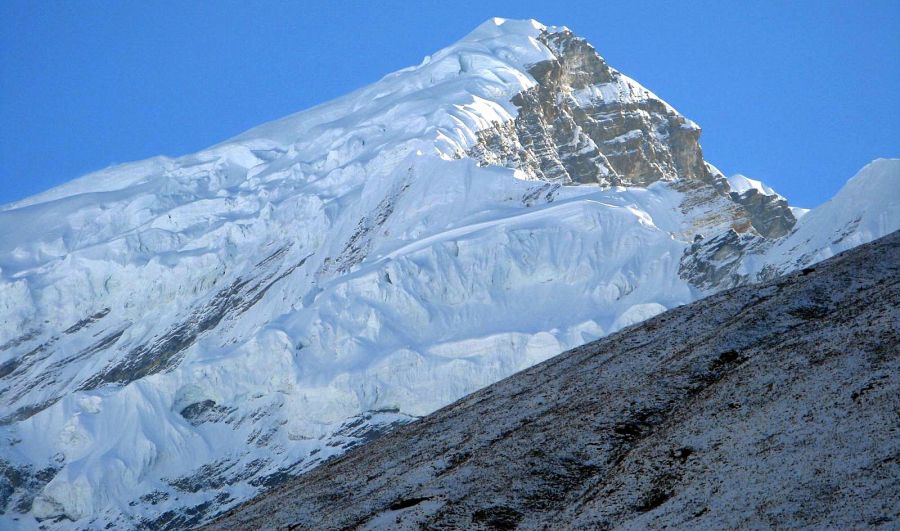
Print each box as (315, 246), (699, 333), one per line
(0, 0), (900, 206)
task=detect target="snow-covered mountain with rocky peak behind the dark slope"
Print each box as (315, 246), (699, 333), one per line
(0, 19), (900, 528)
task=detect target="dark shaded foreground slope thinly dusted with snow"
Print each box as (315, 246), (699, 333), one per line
(211, 232), (900, 529)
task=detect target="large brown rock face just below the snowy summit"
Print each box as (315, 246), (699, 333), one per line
(469, 30), (710, 186)
